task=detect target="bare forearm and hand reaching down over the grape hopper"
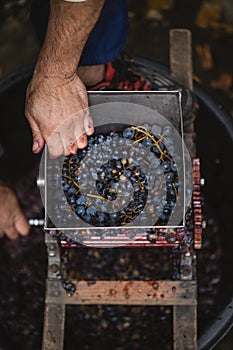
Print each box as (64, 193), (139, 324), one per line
(25, 0), (104, 157)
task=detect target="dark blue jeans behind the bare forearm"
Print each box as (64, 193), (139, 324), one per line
(31, 0), (129, 66)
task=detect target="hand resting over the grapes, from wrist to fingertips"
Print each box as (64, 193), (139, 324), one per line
(26, 74), (94, 157)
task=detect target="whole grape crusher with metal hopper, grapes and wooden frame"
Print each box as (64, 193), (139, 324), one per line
(38, 29), (202, 350)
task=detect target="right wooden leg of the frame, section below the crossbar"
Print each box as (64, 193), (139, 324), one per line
(173, 305), (197, 350)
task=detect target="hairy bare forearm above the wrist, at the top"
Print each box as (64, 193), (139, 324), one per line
(35, 0), (105, 78)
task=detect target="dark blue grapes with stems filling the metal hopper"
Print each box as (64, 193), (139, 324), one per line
(62, 125), (179, 231)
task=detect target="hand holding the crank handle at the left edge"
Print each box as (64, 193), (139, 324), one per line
(0, 182), (30, 239)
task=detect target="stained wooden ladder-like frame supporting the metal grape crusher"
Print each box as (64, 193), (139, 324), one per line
(42, 29), (201, 350)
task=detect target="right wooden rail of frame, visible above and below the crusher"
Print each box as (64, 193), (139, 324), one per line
(169, 29), (197, 350)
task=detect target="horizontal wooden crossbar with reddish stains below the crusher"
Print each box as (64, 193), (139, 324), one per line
(46, 280), (197, 305)
